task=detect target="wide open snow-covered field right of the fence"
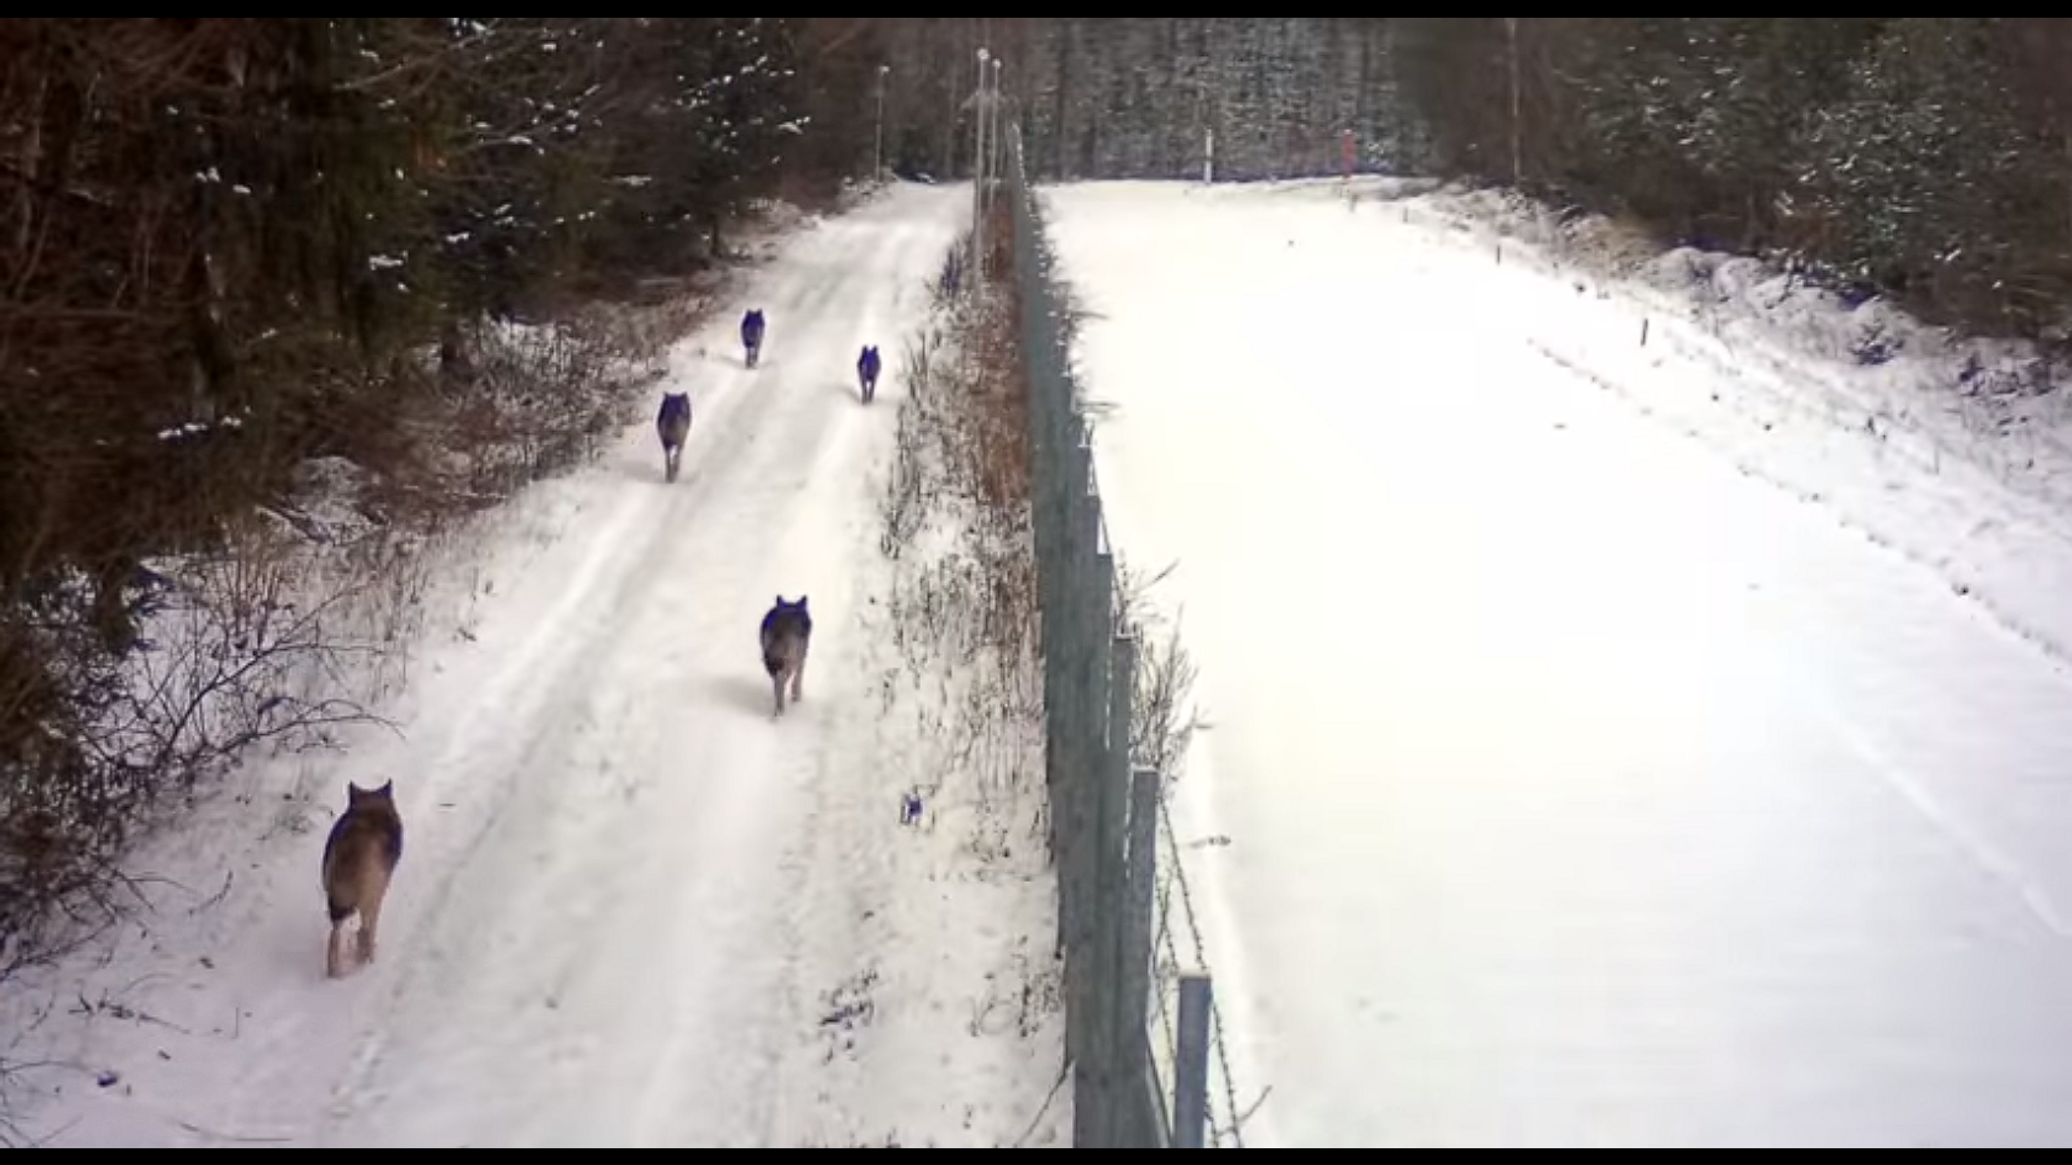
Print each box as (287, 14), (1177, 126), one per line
(1044, 182), (2072, 1146)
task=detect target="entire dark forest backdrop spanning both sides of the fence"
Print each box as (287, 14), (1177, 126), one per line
(0, 17), (2072, 974)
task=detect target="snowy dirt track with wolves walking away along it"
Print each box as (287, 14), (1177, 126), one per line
(10, 187), (968, 1146)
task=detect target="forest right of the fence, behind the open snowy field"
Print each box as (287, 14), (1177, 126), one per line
(1027, 17), (2072, 342)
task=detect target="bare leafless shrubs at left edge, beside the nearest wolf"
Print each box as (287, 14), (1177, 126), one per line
(0, 531), (391, 976)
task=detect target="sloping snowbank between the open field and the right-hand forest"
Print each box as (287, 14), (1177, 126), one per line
(1359, 172), (2072, 657)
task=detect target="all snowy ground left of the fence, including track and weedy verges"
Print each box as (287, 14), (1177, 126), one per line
(0, 187), (1057, 1146)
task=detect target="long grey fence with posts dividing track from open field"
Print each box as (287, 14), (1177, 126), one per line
(1003, 122), (1243, 1148)
